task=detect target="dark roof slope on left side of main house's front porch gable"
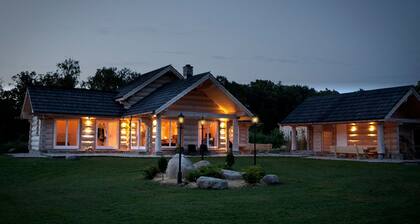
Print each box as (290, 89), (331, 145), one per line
(125, 72), (210, 115)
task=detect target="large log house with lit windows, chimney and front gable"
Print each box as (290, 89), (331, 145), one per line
(21, 65), (253, 154)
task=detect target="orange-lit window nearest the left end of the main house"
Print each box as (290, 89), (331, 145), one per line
(54, 119), (79, 149)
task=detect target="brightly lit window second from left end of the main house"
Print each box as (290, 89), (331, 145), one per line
(96, 120), (119, 149)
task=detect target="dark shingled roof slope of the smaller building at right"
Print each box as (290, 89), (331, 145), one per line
(281, 86), (412, 124)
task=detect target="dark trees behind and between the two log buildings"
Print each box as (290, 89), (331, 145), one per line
(0, 59), (420, 151)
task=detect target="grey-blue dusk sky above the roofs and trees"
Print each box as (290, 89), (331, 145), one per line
(0, 0), (420, 92)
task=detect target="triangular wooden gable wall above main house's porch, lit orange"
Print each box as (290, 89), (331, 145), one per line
(168, 90), (224, 114)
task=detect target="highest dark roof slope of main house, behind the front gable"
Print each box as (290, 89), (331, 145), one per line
(115, 65), (183, 99)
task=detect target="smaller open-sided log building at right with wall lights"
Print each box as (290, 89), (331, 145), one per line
(280, 86), (420, 159)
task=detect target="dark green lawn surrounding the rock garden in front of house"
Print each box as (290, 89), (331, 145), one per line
(0, 156), (420, 224)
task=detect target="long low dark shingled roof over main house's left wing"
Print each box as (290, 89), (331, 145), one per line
(28, 87), (123, 116)
